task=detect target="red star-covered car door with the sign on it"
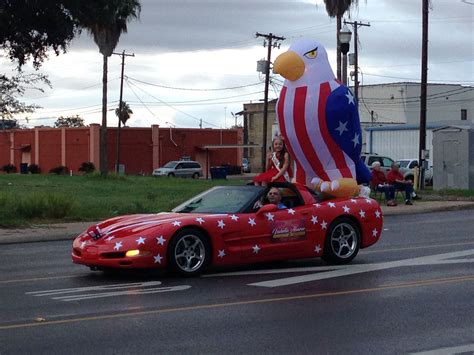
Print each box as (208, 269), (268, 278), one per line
(241, 189), (311, 261)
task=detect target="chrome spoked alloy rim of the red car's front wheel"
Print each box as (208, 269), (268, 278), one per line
(174, 233), (206, 273)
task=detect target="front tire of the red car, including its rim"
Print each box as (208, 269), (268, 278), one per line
(168, 229), (211, 276)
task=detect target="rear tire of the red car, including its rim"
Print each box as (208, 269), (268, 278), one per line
(323, 217), (360, 264)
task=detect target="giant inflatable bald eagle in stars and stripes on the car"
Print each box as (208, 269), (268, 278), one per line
(273, 39), (371, 197)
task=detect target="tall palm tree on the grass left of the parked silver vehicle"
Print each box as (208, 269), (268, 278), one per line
(75, 0), (141, 175)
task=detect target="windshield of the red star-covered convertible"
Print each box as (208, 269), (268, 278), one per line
(172, 186), (264, 213)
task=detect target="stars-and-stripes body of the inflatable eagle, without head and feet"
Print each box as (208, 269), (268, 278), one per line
(277, 80), (370, 184)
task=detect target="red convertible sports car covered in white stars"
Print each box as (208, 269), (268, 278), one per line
(72, 183), (383, 276)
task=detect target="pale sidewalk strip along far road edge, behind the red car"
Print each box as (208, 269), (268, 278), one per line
(0, 200), (474, 244)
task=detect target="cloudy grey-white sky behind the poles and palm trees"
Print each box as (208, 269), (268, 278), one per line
(0, 0), (474, 128)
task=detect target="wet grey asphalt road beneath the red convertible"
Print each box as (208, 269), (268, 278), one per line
(0, 211), (474, 355)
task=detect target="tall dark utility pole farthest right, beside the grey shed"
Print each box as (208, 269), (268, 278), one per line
(418, 0), (429, 190)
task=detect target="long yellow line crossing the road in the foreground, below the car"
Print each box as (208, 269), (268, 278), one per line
(0, 275), (474, 330)
